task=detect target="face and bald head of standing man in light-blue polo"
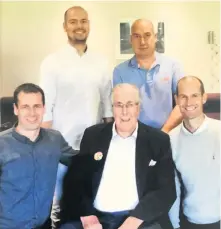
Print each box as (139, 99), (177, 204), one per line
(131, 19), (157, 57)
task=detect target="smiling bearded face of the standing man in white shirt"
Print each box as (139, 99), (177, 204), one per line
(63, 7), (90, 44)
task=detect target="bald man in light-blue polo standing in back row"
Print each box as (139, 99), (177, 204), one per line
(113, 19), (183, 133)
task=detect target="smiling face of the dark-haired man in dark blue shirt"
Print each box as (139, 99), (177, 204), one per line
(14, 92), (45, 131)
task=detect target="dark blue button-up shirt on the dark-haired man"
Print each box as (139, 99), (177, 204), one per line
(0, 128), (73, 229)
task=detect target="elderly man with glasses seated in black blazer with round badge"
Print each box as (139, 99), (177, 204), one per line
(61, 84), (176, 229)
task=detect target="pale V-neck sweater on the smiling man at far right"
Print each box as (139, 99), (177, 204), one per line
(169, 117), (220, 228)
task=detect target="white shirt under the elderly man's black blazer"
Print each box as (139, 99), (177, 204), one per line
(94, 125), (139, 212)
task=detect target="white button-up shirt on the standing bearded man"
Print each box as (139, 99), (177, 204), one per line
(40, 44), (112, 150)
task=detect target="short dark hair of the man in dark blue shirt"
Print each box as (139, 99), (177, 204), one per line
(14, 83), (45, 107)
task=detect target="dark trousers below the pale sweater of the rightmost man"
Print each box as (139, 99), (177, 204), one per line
(180, 216), (220, 229)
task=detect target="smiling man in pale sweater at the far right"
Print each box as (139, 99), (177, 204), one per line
(169, 76), (220, 229)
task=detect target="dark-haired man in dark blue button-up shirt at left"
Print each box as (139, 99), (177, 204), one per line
(0, 83), (73, 229)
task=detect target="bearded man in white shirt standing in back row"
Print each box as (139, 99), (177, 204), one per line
(40, 6), (112, 228)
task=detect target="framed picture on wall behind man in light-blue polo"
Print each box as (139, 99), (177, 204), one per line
(116, 19), (165, 59)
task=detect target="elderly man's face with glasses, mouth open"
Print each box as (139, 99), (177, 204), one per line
(113, 86), (140, 134)
